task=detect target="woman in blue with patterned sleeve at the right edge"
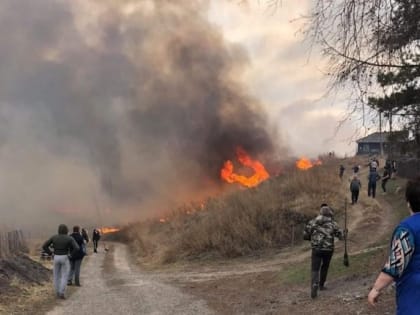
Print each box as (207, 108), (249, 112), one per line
(368, 176), (420, 315)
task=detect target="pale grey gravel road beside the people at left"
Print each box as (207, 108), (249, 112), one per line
(47, 244), (213, 315)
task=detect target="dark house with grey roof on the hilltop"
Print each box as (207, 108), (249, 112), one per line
(356, 130), (409, 155)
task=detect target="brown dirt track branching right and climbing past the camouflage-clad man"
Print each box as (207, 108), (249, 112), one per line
(156, 170), (396, 315)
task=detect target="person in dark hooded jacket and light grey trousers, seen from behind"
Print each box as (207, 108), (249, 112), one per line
(42, 224), (79, 299)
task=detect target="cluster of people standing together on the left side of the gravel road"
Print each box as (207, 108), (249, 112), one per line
(42, 224), (101, 299)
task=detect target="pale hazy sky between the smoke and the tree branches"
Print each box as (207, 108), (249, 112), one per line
(209, 0), (361, 157)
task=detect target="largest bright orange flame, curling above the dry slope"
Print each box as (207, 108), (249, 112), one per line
(220, 147), (270, 187)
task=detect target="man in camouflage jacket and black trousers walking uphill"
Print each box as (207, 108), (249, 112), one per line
(304, 203), (344, 299)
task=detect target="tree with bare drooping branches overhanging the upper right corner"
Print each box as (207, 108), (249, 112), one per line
(307, 0), (420, 154)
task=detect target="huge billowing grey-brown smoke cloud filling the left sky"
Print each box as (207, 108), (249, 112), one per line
(0, 0), (274, 231)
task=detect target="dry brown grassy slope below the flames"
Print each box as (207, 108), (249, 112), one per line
(123, 160), (344, 264)
